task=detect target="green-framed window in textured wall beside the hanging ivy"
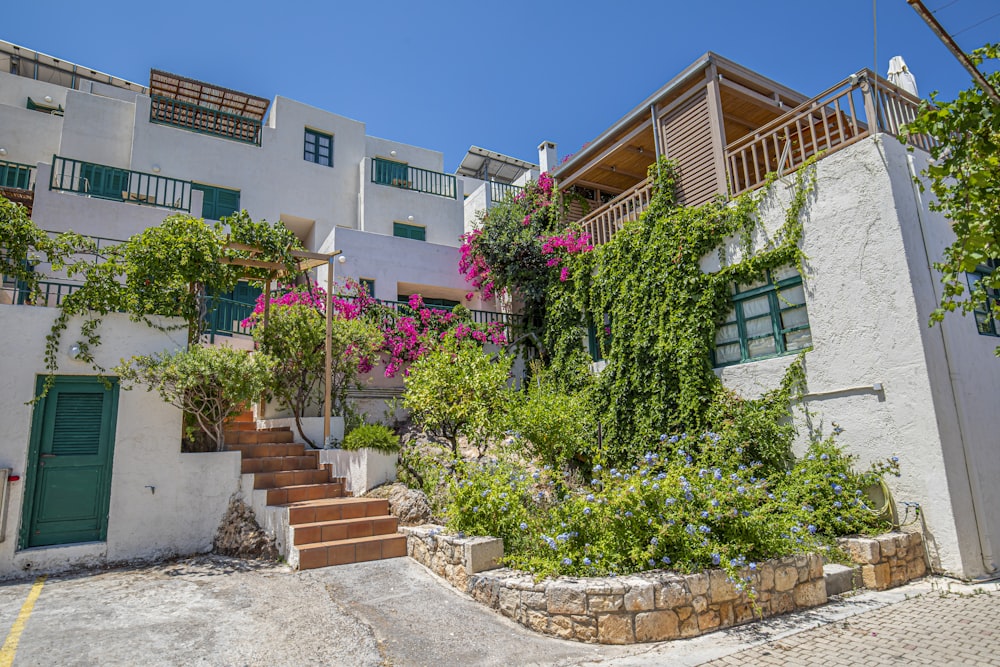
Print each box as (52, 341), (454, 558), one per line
(714, 267), (812, 366)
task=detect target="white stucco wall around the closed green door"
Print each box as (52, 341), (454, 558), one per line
(0, 305), (240, 577)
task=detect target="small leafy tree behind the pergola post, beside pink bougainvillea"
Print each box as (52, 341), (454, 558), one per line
(253, 288), (382, 446)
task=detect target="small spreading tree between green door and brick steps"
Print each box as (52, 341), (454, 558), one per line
(115, 345), (274, 451)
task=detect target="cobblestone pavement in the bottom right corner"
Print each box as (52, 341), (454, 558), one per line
(703, 584), (1000, 667)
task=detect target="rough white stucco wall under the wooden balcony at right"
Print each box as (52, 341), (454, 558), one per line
(703, 137), (1000, 576)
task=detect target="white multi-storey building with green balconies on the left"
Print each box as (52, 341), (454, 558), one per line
(0, 42), (534, 310)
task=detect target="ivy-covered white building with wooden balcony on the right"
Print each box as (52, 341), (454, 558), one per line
(556, 53), (1000, 578)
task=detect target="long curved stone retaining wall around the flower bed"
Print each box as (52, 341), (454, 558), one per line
(400, 526), (826, 644)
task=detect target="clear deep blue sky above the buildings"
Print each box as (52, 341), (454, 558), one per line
(0, 0), (1000, 171)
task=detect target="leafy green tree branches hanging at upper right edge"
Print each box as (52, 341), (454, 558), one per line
(906, 44), (1000, 355)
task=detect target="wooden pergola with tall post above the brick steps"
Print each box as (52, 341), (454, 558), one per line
(220, 241), (341, 446)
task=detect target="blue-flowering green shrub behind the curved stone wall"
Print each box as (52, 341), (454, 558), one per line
(447, 433), (896, 577)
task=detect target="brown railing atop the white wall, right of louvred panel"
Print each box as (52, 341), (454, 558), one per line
(726, 70), (933, 195)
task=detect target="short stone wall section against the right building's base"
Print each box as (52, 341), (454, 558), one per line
(837, 532), (927, 591)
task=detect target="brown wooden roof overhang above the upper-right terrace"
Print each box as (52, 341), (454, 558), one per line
(553, 52), (807, 198)
